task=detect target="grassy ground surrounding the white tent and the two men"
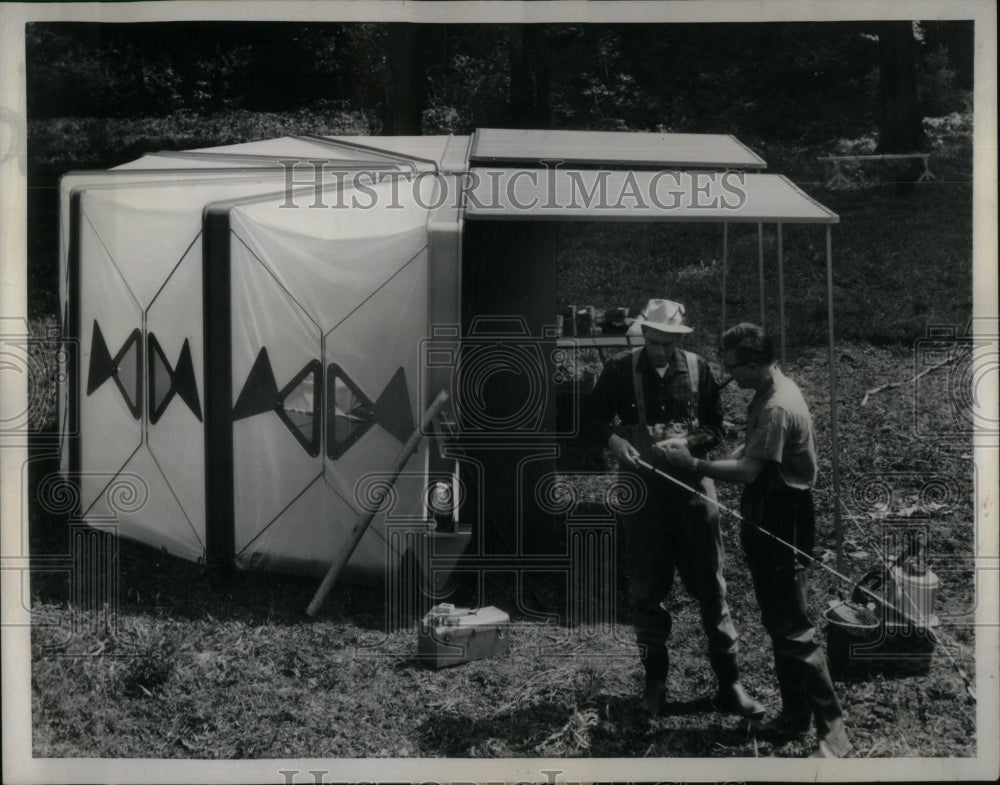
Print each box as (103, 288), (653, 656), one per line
(23, 112), (977, 759)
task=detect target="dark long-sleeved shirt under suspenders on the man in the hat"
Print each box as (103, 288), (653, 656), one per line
(590, 348), (722, 456)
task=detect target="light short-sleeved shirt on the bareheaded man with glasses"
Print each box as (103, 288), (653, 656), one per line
(743, 367), (817, 488)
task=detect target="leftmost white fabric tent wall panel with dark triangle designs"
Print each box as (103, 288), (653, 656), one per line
(61, 174), (308, 560)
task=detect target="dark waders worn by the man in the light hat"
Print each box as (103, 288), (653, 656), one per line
(621, 475), (739, 684)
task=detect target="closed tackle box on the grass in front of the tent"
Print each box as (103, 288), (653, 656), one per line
(417, 603), (510, 668)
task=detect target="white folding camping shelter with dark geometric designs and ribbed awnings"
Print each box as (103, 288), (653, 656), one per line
(60, 129), (840, 596)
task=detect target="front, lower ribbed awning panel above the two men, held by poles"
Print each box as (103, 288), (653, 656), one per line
(465, 168), (839, 223)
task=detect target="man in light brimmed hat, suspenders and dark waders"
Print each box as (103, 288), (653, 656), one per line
(591, 300), (764, 717)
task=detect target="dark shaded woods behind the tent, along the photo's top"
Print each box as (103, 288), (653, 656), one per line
(27, 22), (973, 316)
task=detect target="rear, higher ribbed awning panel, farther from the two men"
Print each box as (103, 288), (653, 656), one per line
(469, 128), (767, 169)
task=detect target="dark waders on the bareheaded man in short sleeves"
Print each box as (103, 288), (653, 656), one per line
(741, 478), (846, 748)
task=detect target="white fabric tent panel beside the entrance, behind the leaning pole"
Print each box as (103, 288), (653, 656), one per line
(229, 178), (429, 577)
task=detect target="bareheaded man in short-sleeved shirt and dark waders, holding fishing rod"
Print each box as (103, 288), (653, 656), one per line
(663, 324), (851, 757)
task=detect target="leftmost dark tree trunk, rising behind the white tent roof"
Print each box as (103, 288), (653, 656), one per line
(382, 22), (426, 136)
